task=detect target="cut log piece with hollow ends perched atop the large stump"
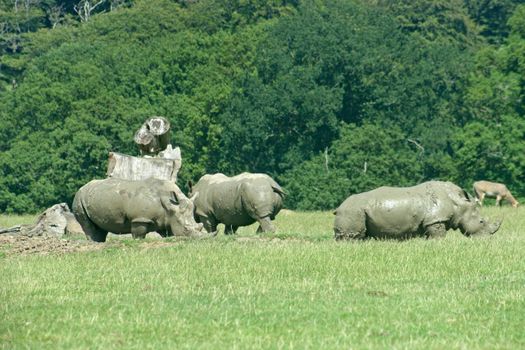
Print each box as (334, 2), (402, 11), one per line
(133, 116), (171, 155)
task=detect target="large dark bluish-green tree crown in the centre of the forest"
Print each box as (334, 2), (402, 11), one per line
(219, 2), (469, 180)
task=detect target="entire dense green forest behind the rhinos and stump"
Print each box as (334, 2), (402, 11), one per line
(0, 0), (525, 213)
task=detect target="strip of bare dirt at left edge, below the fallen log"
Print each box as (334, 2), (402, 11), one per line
(0, 235), (104, 255)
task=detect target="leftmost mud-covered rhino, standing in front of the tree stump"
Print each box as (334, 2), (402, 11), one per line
(73, 178), (202, 242)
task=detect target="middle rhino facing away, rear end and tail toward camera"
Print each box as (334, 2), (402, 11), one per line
(190, 173), (284, 234)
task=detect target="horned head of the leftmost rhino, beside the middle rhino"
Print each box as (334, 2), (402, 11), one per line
(161, 188), (205, 237)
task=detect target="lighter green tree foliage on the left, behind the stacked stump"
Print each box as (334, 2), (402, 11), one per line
(0, 1), (272, 212)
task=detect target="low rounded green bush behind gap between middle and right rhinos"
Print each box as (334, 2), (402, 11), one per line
(283, 124), (424, 210)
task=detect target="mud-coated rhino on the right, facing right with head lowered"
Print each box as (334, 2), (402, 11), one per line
(334, 181), (501, 240)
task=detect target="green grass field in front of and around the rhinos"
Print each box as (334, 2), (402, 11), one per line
(0, 207), (525, 349)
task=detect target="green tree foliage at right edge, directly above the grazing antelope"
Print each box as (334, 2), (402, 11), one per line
(452, 2), (525, 194)
